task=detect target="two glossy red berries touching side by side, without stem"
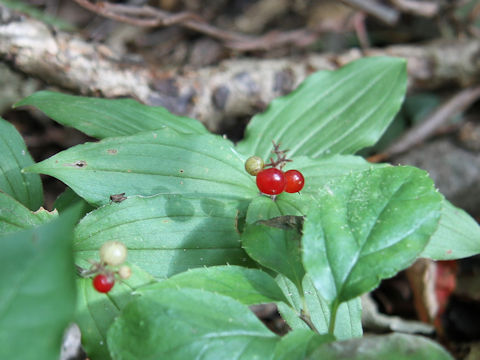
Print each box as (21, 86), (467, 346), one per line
(257, 168), (305, 195)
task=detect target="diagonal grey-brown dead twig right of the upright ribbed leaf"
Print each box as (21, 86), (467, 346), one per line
(369, 86), (480, 162)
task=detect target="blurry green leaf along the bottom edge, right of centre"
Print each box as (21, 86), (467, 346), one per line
(305, 333), (453, 360)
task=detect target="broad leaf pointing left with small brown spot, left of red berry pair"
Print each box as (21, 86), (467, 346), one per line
(27, 128), (257, 205)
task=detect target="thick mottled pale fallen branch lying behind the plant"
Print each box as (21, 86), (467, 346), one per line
(0, 5), (480, 131)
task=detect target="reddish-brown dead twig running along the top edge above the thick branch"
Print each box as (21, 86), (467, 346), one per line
(74, 0), (321, 51)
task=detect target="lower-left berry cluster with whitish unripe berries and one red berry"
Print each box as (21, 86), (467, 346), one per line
(80, 241), (132, 293)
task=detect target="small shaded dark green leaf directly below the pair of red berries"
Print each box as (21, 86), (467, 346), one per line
(242, 225), (305, 289)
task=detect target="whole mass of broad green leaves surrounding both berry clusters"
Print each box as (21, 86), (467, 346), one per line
(0, 57), (480, 359)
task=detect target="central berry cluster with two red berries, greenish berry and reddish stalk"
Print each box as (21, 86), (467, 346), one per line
(245, 143), (305, 196)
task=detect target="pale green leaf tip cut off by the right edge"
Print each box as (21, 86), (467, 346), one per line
(420, 199), (480, 260)
